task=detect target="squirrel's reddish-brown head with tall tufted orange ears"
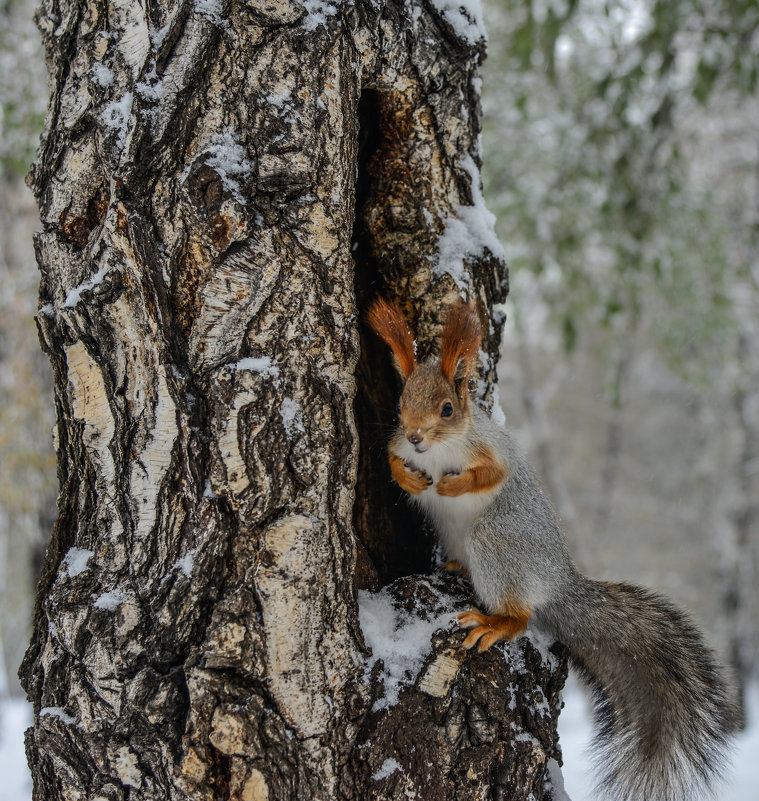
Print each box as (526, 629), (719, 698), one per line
(368, 298), (482, 453)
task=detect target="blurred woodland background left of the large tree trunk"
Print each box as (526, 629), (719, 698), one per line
(0, 0), (56, 696)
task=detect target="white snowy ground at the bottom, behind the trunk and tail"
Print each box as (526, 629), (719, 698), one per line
(0, 679), (759, 801)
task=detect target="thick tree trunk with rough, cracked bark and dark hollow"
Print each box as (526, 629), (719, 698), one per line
(21, 0), (563, 801)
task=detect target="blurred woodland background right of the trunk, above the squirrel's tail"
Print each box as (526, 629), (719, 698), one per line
(483, 0), (759, 716)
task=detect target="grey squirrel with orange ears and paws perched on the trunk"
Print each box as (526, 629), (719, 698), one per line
(368, 299), (740, 801)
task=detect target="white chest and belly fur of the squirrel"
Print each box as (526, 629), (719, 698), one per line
(394, 440), (499, 567)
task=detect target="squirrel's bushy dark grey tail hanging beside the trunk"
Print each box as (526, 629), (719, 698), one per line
(545, 576), (738, 801)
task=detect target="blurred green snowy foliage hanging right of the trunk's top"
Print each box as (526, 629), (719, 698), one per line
(483, 0), (759, 381)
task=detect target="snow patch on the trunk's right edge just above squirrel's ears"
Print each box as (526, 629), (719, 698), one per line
(433, 156), (504, 290)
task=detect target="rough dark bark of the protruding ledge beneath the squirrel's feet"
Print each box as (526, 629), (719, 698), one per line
(354, 575), (567, 801)
